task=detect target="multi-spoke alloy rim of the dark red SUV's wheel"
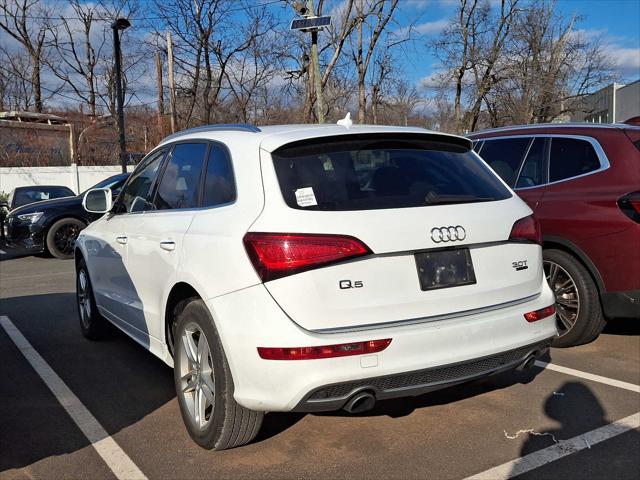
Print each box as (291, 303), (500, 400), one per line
(544, 260), (580, 337)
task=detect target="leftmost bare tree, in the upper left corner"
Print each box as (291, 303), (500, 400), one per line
(0, 0), (50, 112)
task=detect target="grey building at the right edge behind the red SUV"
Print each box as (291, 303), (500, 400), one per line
(571, 80), (640, 123)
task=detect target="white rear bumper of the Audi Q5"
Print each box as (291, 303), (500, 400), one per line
(207, 281), (557, 411)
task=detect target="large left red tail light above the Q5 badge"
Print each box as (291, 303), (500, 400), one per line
(244, 232), (371, 282)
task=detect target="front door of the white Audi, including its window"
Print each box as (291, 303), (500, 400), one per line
(86, 148), (166, 345)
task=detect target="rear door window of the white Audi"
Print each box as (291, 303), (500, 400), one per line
(154, 143), (207, 210)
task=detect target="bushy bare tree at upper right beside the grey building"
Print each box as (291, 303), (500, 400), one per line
(486, 1), (615, 123)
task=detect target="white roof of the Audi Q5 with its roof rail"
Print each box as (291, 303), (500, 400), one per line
(162, 124), (471, 152)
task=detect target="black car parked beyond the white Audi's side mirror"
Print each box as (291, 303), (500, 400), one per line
(3, 173), (129, 259)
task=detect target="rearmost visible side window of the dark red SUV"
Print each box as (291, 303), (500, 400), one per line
(549, 137), (600, 182)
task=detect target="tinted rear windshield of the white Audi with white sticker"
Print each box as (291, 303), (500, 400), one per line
(272, 134), (511, 211)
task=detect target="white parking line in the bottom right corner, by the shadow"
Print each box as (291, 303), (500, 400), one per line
(466, 412), (640, 480)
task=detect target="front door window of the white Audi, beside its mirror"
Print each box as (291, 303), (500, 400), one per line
(115, 149), (165, 213)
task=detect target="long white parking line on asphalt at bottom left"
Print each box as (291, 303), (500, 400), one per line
(0, 315), (147, 480)
